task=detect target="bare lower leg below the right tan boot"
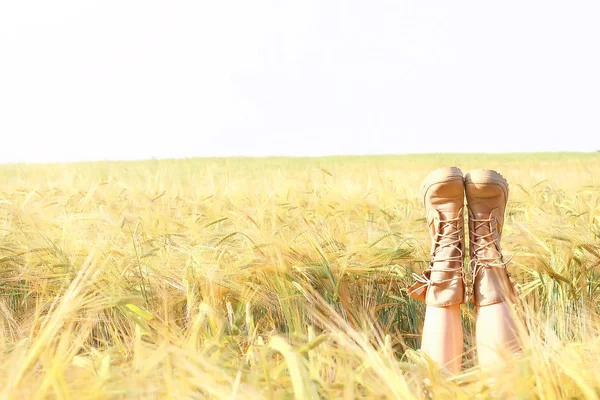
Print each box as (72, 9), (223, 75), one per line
(476, 301), (518, 368)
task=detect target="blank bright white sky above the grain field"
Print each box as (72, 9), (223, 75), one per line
(0, 0), (600, 163)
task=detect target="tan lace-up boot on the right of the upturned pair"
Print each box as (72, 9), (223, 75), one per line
(465, 170), (516, 306)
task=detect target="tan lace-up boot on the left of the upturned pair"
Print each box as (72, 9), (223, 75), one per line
(408, 167), (467, 307)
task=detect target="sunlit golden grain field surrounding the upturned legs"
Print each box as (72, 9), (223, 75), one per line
(0, 153), (600, 399)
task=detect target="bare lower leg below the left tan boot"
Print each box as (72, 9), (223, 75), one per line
(421, 304), (463, 374)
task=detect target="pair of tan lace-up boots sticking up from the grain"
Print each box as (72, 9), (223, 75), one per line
(408, 167), (516, 307)
